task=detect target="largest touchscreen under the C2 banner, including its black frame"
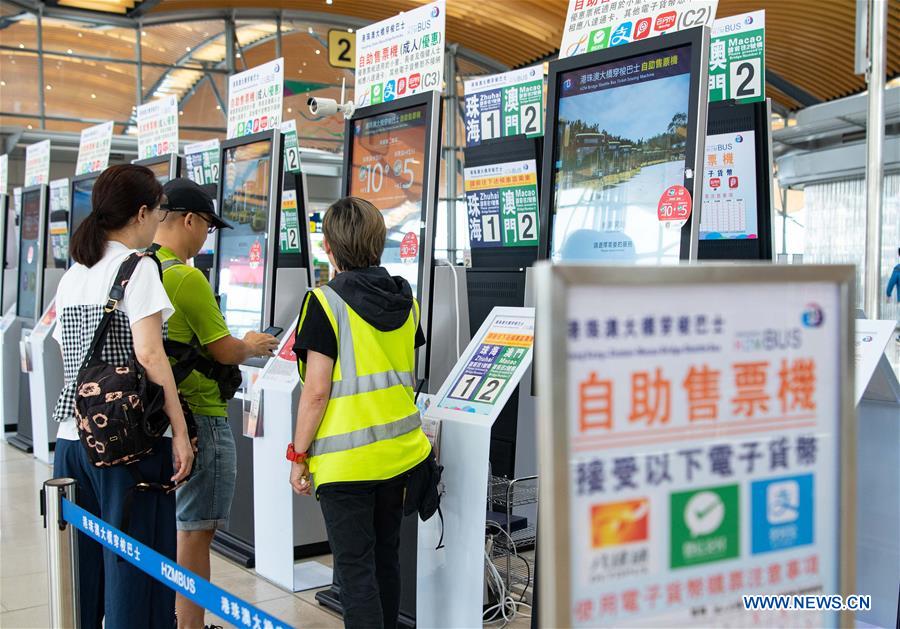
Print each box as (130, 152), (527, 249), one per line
(541, 27), (709, 265)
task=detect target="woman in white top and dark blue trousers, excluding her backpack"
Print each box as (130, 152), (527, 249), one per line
(53, 164), (194, 629)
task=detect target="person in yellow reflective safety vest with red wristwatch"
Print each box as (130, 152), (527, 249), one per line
(288, 197), (431, 628)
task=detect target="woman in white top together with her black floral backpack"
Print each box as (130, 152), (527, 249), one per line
(53, 164), (194, 629)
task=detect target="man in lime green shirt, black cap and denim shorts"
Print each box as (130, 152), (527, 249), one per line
(155, 178), (278, 629)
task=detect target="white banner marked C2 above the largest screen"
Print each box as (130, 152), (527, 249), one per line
(559, 0), (719, 59)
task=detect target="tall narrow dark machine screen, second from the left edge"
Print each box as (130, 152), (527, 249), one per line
(16, 186), (47, 323)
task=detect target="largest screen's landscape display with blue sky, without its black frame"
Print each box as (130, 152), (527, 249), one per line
(547, 46), (691, 264)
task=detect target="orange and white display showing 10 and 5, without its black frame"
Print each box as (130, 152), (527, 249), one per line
(350, 105), (428, 298)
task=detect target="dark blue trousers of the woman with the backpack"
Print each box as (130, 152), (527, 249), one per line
(53, 439), (176, 629)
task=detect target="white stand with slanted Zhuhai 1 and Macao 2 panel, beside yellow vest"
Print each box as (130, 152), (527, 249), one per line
(416, 308), (534, 628)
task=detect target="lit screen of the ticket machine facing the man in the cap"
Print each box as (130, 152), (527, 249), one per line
(217, 140), (272, 338)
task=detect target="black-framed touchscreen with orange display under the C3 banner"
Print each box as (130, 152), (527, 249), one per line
(343, 92), (441, 375)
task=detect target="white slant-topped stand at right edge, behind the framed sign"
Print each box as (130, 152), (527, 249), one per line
(856, 319), (900, 627)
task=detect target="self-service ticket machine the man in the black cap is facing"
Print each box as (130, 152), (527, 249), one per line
(213, 131), (325, 566)
